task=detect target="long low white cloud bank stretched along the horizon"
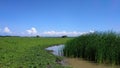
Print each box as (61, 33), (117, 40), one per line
(43, 30), (94, 36)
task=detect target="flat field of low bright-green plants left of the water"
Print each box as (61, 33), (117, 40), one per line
(0, 37), (70, 68)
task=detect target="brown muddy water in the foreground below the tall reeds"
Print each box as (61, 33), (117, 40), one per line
(66, 58), (120, 68)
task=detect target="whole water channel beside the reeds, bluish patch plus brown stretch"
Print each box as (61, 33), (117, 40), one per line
(46, 45), (120, 68)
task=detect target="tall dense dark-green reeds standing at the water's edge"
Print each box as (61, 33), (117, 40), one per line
(64, 32), (120, 65)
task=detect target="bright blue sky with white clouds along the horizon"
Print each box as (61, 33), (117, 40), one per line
(0, 0), (120, 36)
